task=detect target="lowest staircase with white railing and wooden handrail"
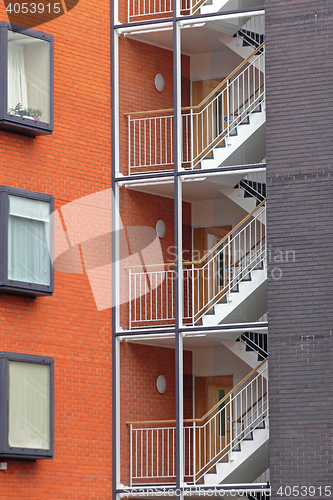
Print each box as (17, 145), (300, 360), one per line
(127, 358), (269, 486)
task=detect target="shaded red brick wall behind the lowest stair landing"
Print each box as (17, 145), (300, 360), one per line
(120, 341), (193, 485)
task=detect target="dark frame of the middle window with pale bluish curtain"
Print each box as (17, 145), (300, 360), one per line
(0, 186), (54, 298)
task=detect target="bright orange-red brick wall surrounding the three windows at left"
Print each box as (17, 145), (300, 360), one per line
(0, 0), (111, 500)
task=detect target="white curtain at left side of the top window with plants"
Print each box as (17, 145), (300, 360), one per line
(8, 40), (28, 109)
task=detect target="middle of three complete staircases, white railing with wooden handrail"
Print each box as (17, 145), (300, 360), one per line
(128, 200), (267, 329)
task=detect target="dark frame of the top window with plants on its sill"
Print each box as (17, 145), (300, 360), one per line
(0, 21), (54, 137)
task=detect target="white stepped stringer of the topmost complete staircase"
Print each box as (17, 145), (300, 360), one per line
(201, 107), (266, 170)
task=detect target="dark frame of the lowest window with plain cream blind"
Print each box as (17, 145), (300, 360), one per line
(0, 351), (54, 460)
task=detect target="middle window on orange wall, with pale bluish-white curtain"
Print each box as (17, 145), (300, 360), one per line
(0, 186), (54, 297)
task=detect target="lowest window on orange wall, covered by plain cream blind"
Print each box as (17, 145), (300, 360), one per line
(0, 352), (54, 460)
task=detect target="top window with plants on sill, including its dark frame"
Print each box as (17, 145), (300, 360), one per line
(0, 22), (53, 137)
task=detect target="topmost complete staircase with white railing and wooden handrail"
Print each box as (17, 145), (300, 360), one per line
(126, 43), (266, 175)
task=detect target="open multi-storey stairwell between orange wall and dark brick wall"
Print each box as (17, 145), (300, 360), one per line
(112, 1), (268, 498)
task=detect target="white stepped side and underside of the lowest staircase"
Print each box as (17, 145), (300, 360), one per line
(204, 425), (269, 486)
